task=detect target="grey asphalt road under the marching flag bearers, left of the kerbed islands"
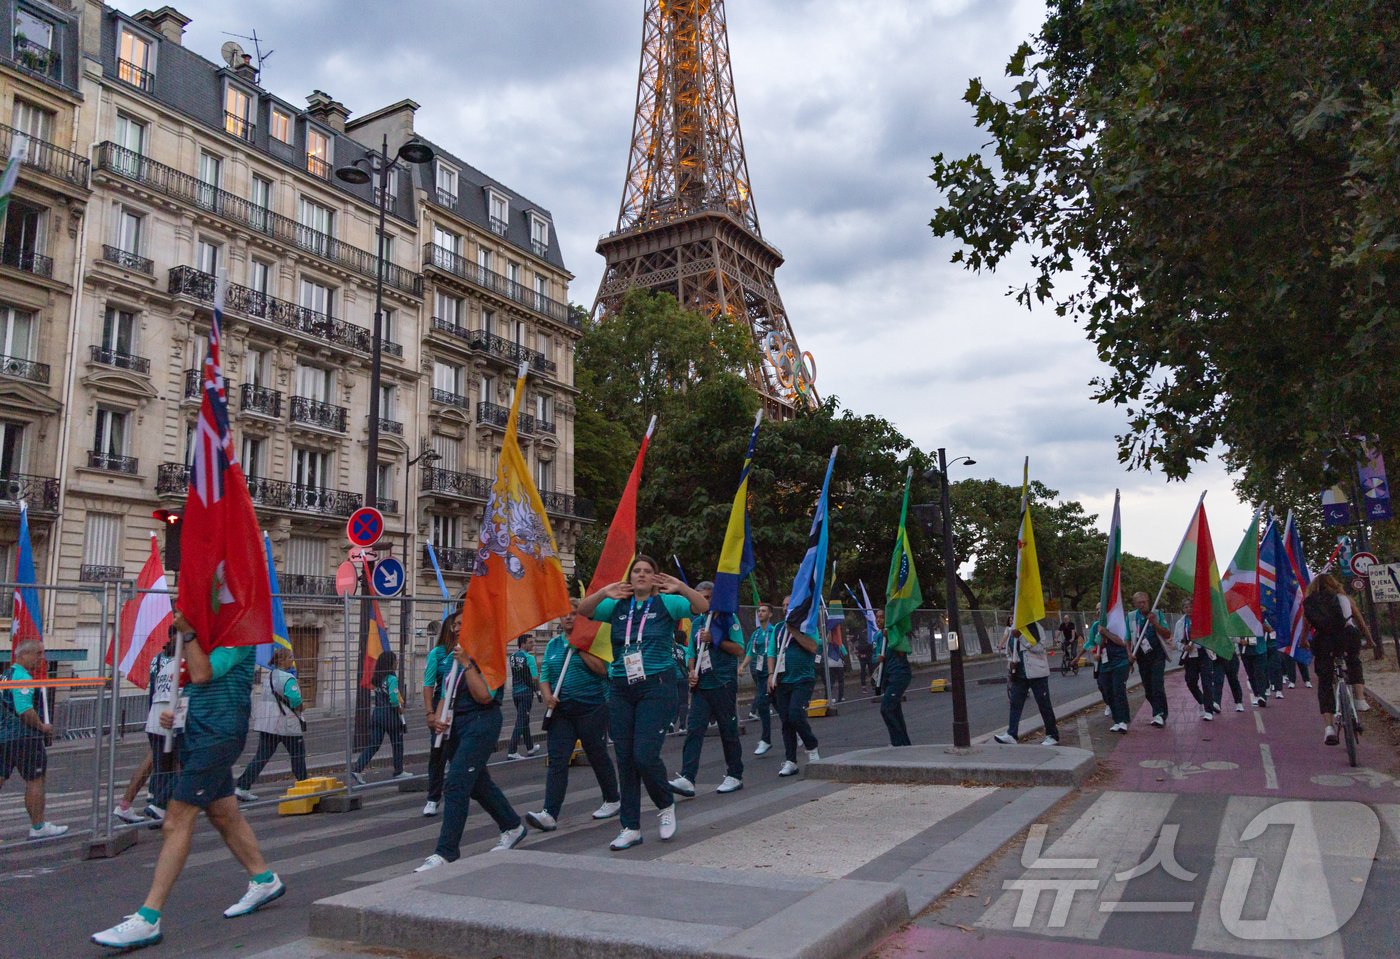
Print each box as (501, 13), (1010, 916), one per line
(0, 661), (1093, 958)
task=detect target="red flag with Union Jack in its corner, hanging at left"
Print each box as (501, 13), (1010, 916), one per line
(176, 272), (272, 652)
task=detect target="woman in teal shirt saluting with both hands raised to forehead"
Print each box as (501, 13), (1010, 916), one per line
(578, 554), (710, 851)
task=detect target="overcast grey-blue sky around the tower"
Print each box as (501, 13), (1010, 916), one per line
(116, 0), (1249, 565)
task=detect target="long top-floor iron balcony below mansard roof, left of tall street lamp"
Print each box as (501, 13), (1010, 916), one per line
(97, 143), (423, 295)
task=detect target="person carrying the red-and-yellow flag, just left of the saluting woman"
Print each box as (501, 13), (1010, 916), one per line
(525, 599), (622, 833)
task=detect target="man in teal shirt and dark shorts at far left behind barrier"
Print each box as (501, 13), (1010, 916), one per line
(0, 640), (69, 839)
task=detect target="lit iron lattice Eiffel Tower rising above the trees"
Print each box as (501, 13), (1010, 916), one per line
(594, 0), (818, 416)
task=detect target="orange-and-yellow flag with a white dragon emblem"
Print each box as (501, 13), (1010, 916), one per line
(458, 364), (568, 689)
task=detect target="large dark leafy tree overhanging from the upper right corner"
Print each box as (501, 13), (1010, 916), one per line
(931, 0), (1400, 503)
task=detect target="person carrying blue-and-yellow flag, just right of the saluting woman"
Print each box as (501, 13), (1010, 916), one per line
(671, 580), (743, 798)
